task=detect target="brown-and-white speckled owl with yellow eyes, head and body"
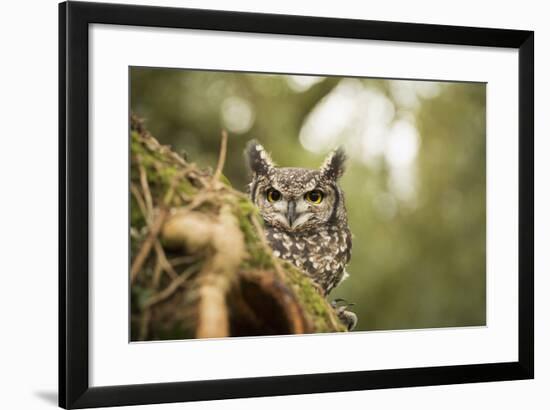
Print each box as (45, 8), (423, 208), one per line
(245, 141), (351, 296)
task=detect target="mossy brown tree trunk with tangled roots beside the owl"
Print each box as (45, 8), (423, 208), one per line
(130, 116), (345, 340)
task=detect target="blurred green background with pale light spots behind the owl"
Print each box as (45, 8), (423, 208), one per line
(130, 67), (486, 331)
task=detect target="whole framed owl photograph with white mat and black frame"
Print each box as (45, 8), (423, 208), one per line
(59, 2), (534, 408)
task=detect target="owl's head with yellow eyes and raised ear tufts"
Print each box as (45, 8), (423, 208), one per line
(245, 141), (346, 232)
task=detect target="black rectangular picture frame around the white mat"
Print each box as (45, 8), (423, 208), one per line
(59, 1), (534, 408)
